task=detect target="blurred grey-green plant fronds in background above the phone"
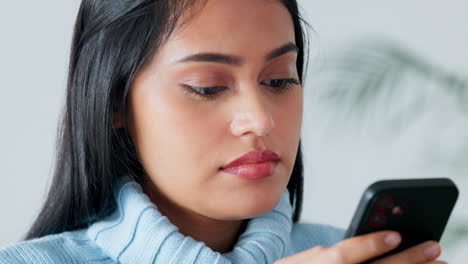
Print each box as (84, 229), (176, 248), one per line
(306, 39), (468, 248)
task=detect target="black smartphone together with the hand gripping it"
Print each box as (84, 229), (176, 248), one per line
(275, 178), (458, 264)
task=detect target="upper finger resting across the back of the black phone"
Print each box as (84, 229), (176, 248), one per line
(325, 231), (401, 263)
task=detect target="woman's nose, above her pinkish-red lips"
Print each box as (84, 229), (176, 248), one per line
(231, 89), (275, 136)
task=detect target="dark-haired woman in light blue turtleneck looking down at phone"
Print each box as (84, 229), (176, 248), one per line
(0, 0), (446, 263)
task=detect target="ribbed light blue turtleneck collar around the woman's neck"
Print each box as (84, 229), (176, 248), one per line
(87, 176), (292, 264)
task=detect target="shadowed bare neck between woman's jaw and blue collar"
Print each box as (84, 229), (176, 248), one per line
(143, 184), (248, 253)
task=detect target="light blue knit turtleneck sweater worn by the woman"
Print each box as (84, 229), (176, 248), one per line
(0, 177), (343, 264)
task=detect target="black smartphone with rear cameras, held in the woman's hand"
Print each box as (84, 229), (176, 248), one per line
(345, 178), (458, 263)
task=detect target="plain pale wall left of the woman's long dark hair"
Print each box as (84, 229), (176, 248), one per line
(0, 0), (79, 246)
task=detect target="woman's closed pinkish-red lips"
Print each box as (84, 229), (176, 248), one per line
(221, 150), (280, 180)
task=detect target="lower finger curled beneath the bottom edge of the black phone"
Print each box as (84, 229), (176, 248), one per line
(373, 241), (441, 264)
